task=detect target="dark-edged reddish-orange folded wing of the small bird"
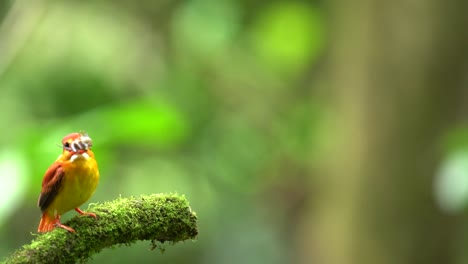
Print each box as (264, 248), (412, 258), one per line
(37, 163), (64, 211)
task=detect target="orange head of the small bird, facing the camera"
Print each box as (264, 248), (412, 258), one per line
(62, 131), (93, 160)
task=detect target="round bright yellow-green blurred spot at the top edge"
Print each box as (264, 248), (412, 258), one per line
(251, 1), (325, 73)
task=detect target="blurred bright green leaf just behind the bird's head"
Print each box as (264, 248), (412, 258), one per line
(32, 100), (189, 148)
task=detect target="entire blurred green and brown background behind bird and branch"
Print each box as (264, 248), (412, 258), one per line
(0, 0), (468, 264)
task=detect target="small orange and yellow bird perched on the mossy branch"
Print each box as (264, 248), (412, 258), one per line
(37, 132), (99, 232)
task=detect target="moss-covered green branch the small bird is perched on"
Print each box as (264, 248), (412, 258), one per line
(5, 194), (198, 263)
